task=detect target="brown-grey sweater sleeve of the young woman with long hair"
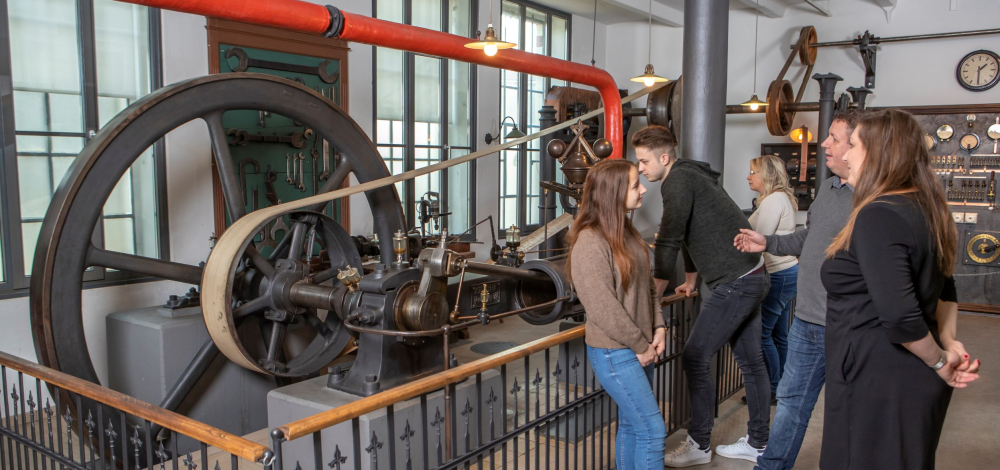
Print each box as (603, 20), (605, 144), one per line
(570, 231), (656, 354)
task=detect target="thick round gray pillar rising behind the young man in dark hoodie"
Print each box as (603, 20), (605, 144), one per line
(681, 0), (729, 173)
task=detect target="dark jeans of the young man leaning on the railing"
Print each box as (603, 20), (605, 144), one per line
(681, 270), (771, 448)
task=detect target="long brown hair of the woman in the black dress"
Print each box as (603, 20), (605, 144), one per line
(826, 109), (958, 276)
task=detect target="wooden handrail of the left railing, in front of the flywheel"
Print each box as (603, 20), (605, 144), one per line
(0, 352), (270, 462)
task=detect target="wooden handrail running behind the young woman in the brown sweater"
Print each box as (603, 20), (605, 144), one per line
(277, 291), (698, 440)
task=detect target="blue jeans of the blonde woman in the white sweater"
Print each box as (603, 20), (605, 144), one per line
(760, 264), (799, 394)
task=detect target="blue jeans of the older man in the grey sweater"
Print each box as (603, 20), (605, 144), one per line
(754, 318), (826, 470)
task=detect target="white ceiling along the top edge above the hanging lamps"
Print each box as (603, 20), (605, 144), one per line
(534, 0), (898, 27)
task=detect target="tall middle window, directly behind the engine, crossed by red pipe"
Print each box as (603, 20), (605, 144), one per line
(374, 0), (478, 233)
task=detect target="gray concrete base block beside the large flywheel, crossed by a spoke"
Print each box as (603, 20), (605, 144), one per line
(106, 307), (276, 452)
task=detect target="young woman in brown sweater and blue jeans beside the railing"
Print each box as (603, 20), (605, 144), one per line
(566, 160), (667, 470)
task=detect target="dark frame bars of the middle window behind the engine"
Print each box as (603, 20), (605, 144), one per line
(372, 0), (479, 237)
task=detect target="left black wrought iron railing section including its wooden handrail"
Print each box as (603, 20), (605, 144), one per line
(0, 352), (273, 470)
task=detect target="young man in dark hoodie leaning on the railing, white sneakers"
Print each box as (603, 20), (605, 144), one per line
(632, 126), (771, 467)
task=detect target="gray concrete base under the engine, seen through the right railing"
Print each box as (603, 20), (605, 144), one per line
(267, 370), (504, 469)
